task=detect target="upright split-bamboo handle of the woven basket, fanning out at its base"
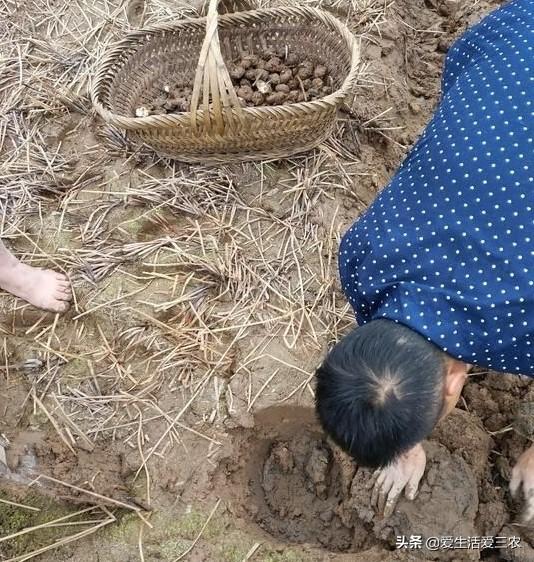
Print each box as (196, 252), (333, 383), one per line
(191, 0), (244, 135)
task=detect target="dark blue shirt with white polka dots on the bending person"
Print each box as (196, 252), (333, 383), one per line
(339, 0), (534, 376)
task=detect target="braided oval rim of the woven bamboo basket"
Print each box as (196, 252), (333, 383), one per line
(90, 6), (360, 131)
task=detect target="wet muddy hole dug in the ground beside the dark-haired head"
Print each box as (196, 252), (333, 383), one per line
(224, 407), (379, 552)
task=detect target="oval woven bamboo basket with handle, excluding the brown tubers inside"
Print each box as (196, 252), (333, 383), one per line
(91, 0), (359, 163)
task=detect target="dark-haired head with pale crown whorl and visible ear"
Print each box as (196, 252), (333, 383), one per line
(315, 319), (468, 468)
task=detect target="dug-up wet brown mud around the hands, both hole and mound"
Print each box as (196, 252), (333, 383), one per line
(214, 396), (531, 560)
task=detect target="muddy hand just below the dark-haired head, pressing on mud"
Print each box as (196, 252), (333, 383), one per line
(368, 444), (426, 517)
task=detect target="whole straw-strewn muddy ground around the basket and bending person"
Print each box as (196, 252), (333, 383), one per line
(0, 0), (534, 562)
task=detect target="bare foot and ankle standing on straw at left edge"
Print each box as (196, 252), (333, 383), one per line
(0, 240), (72, 312)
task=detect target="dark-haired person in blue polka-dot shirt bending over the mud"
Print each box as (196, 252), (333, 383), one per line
(316, 0), (534, 520)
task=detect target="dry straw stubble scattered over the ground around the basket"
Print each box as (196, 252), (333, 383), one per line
(0, 0), (398, 560)
